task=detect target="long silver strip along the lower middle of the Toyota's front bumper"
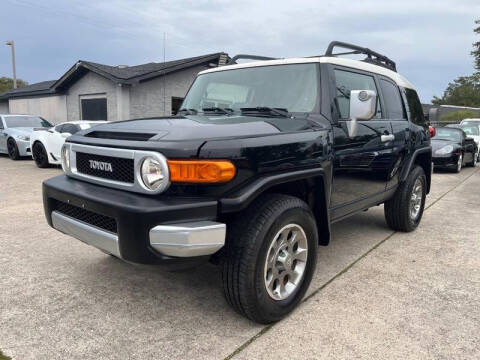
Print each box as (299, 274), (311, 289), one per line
(52, 211), (121, 258)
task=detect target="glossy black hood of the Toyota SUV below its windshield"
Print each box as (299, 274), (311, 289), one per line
(79, 115), (319, 141)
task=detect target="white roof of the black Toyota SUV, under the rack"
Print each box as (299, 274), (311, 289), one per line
(199, 56), (415, 89)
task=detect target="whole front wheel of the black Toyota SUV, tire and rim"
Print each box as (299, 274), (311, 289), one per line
(222, 194), (318, 324)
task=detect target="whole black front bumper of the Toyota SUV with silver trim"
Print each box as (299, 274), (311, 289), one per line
(43, 175), (226, 264)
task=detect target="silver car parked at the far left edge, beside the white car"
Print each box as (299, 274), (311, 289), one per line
(0, 114), (52, 160)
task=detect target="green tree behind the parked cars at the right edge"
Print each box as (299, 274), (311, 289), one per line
(432, 72), (480, 107)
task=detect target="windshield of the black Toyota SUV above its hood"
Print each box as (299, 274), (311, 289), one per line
(182, 64), (318, 113)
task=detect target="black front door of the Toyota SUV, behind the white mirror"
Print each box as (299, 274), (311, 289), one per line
(330, 68), (393, 220)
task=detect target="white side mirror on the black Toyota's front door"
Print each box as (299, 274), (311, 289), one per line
(347, 90), (377, 137)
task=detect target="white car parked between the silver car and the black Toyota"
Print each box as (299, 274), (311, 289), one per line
(30, 121), (108, 168)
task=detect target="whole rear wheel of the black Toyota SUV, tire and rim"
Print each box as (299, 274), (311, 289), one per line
(384, 166), (427, 232)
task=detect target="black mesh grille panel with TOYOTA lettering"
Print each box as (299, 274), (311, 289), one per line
(76, 152), (134, 183)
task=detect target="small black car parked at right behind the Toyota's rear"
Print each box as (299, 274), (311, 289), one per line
(431, 127), (478, 173)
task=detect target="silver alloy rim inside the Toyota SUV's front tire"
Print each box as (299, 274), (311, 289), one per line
(264, 224), (308, 300)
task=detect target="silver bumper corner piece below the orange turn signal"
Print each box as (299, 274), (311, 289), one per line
(150, 221), (227, 257)
